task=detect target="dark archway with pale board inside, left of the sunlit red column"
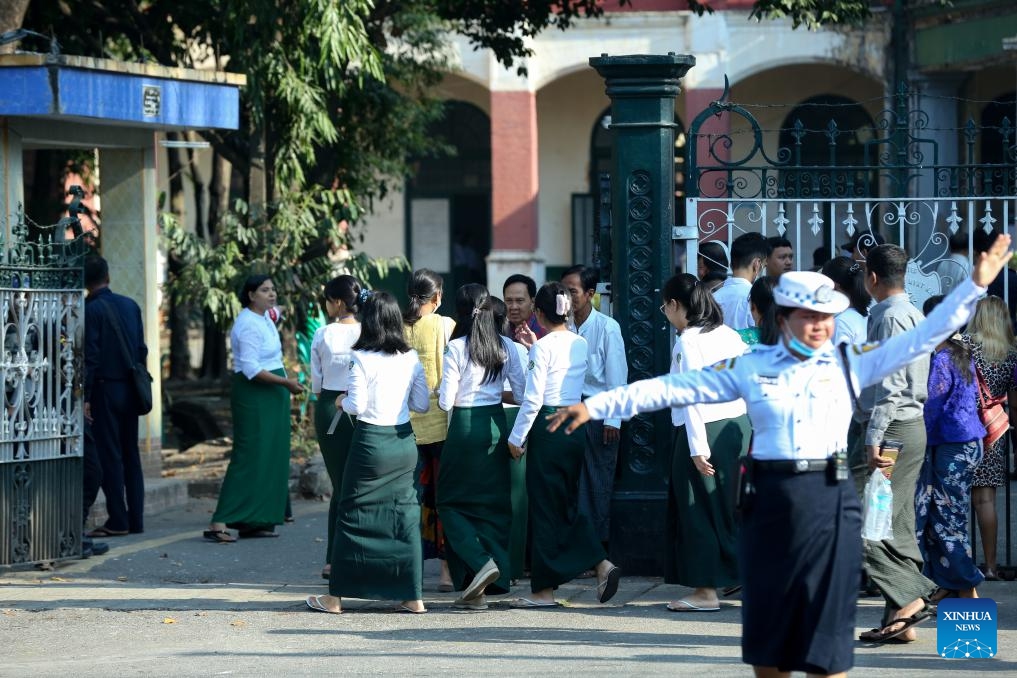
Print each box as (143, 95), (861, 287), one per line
(406, 101), (491, 299)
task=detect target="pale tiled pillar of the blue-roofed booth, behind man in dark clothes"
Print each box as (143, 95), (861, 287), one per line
(99, 145), (163, 477)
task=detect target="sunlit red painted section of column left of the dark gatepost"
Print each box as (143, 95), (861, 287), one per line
(491, 91), (538, 252)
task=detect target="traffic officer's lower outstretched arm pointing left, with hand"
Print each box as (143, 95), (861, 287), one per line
(547, 358), (746, 433)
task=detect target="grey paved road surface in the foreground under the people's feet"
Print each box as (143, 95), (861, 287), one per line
(0, 500), (1017, 678)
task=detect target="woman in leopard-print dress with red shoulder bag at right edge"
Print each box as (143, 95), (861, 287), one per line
(965, 297), (1017, 581)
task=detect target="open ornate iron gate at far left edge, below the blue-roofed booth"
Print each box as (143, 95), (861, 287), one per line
(0, 203), (85, 565)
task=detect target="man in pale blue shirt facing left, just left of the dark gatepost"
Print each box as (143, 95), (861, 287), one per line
(561, 264), (629, 548)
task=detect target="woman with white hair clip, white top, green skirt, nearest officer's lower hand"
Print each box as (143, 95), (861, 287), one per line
(509, 283), (621, 608)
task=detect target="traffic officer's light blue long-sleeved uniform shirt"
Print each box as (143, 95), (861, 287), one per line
(586, 279), (985, 459)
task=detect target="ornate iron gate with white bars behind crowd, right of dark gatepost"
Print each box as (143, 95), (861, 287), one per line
(675, 82), (1017, 307)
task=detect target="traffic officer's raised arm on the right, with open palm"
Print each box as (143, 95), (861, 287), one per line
(848, 234), (1011, 387)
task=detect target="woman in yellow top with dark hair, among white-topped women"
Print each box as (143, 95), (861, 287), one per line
(403, 268), (456, 593)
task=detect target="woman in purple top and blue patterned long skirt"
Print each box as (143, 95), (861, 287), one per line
(919, 296), (985, 602)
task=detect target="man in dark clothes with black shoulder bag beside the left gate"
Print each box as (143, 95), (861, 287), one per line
(84, 256), (148, 537)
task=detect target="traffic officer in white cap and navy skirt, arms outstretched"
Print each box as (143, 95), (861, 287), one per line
(549, 235), (1010, 676)
